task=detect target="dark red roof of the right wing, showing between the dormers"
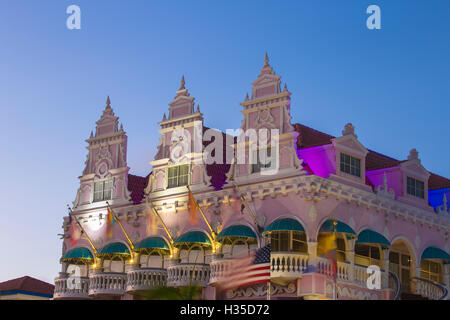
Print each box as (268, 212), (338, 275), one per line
(294, 123), (450, 190)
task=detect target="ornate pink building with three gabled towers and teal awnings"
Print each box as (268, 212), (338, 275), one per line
(54, 55), (450, 299)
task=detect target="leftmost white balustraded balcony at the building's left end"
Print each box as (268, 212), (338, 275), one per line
(53, 275), (90, 300)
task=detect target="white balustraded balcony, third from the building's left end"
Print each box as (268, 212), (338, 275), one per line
(127, 268), (167, 292)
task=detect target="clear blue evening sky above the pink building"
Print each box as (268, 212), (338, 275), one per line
(0, 0), (450, 282)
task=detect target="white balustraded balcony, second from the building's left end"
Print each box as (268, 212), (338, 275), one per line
(89, 272), (127, 296)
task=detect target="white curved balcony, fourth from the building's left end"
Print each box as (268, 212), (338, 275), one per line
(167, 263), (210, 287)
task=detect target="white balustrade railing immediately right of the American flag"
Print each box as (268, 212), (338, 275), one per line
(270, 252), (308, 278)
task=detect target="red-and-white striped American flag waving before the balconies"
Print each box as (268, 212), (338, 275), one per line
(219, 244), (270, 290)
